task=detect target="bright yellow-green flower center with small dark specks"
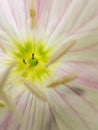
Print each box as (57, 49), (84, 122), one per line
(12, 38), (51, 85)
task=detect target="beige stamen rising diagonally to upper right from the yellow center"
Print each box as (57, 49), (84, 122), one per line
(45, 41), (76, 67)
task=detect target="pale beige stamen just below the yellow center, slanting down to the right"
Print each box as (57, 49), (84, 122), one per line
(22, 78), (47, 101)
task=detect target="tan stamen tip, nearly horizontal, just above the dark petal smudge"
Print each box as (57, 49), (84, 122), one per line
(47, 74), (77, 88)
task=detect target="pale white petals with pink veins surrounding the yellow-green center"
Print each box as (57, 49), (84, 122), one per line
(0, 0), (98, 130)
